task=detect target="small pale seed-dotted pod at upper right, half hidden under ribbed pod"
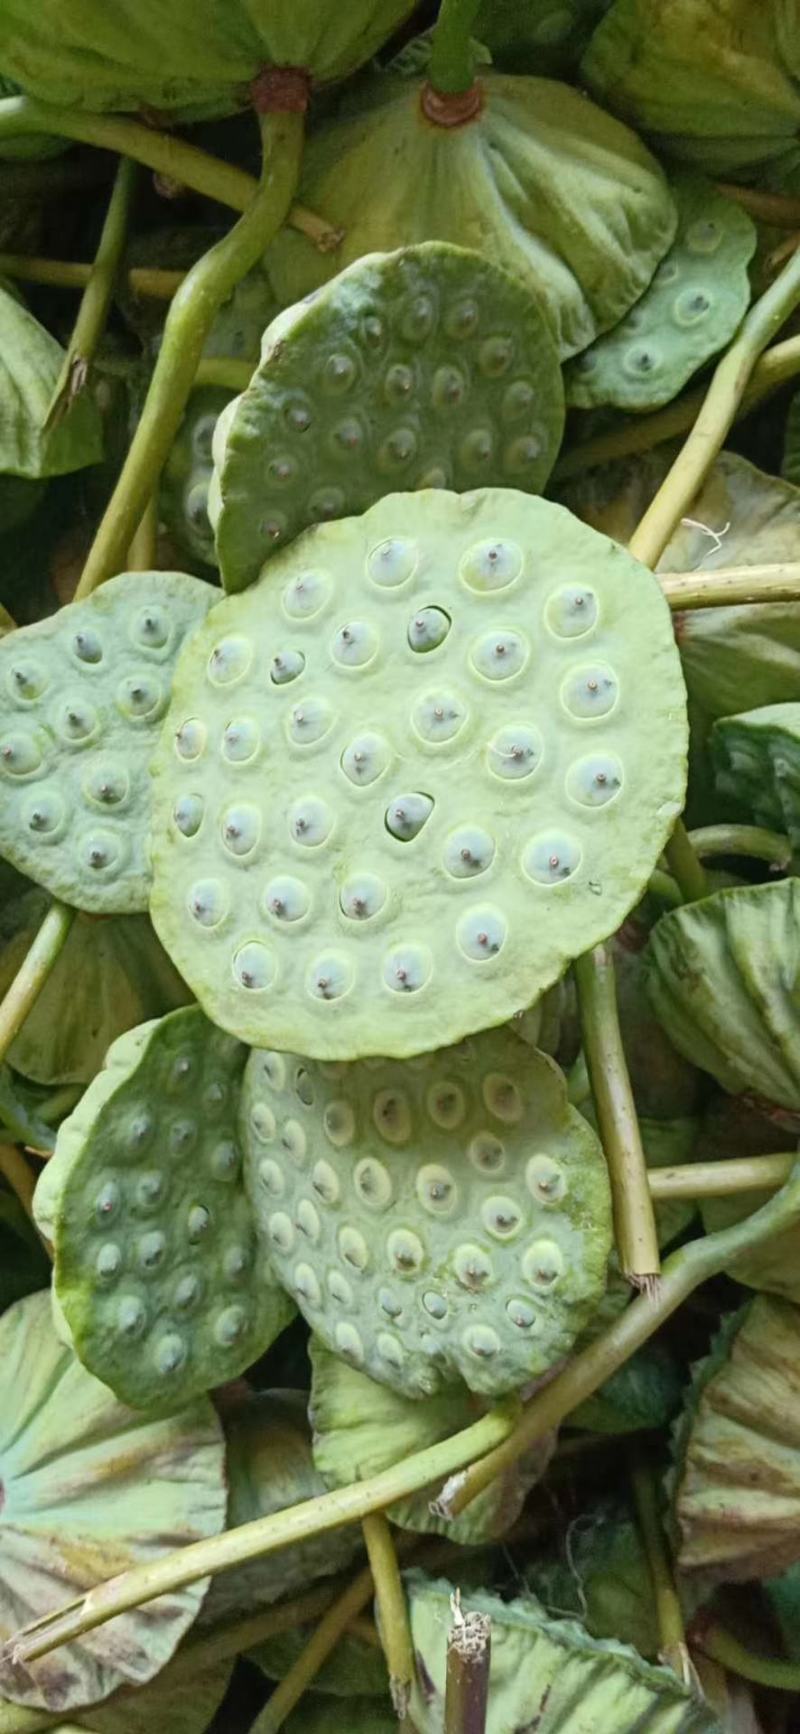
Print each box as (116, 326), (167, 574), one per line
(566, 175), (757, 409)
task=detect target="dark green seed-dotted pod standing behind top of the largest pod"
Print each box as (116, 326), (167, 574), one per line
(210, 241), (564, 590)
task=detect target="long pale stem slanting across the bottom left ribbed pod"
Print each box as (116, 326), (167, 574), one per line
(0, 1394), (510, 1661)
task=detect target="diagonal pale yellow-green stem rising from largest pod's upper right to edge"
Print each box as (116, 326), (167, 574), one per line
(628, 251), (800, 569)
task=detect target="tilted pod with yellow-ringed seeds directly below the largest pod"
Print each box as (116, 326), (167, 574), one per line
(241, 1030), (611, 1396)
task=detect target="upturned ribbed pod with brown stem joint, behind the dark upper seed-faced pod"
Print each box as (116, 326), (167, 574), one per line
(266, 71), (677, 359)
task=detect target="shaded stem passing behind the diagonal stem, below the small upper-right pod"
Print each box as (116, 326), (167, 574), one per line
(554, 336), (800, 482)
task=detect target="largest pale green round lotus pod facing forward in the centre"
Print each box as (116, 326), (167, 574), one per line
(151, 489), (687, 1059)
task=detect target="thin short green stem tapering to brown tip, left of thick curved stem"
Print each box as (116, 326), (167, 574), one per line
(45, 156), (137, 428)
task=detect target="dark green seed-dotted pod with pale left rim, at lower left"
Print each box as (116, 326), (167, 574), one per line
(35, 1006), (295, 1411)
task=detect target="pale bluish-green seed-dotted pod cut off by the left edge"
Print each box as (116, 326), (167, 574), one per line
(0, 572), (217, 916)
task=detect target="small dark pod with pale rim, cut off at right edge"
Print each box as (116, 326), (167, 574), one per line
(711, 704), (800, 850)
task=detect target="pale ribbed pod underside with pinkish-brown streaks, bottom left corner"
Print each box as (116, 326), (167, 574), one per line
(0, 1294), (226, 1725)
